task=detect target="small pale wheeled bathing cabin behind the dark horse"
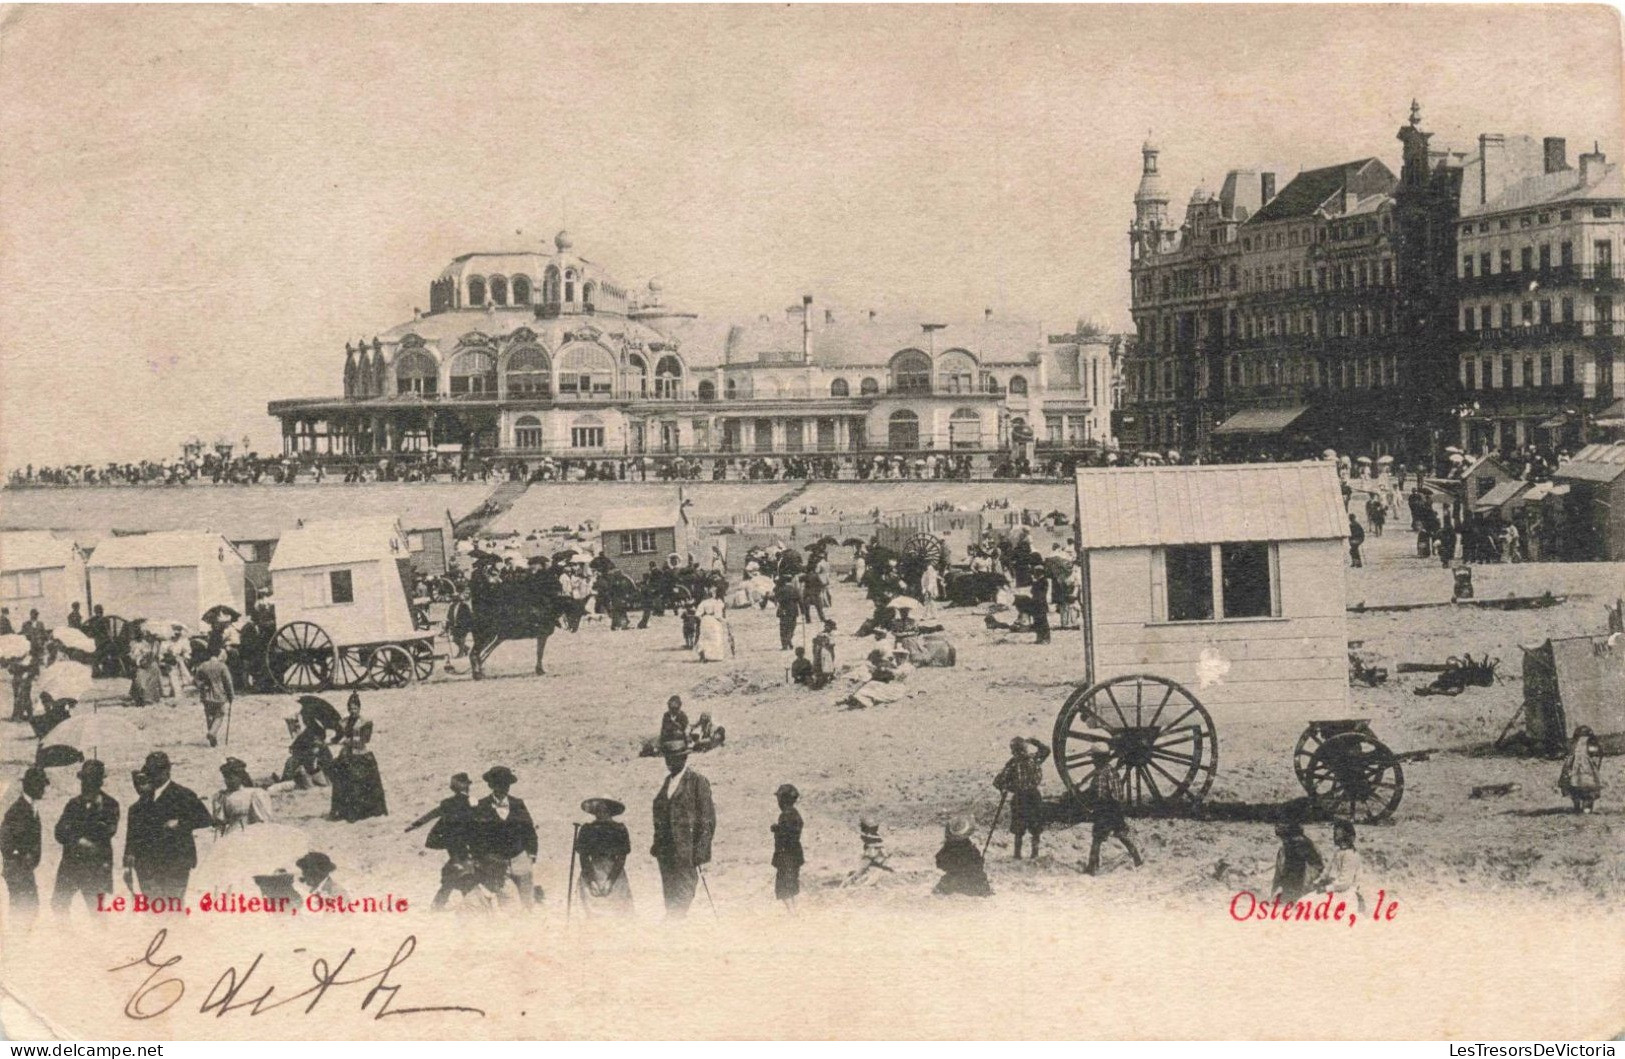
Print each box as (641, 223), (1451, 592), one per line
(265, 518), (436, 692)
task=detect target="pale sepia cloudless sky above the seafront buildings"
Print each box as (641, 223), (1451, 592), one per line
(0, 5), (1625, 468)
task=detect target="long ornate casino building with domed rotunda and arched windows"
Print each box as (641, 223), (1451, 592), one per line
(268, 232), (1116, 461)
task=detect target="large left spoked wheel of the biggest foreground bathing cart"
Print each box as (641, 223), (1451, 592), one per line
(1053, 674), (1219, 807)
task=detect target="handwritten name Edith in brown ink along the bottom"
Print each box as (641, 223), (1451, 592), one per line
(107, 929), (486, 1020)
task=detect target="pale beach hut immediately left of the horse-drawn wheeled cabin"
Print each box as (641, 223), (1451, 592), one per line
(86, 530), (247, 629)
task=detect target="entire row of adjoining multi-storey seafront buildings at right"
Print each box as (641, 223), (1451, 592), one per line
(1118, 102), (1625, 455)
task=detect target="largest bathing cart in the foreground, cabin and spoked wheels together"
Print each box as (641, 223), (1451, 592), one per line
(1053, 463), (1404, 822)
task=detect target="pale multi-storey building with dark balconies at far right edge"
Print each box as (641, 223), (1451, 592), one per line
(1454, 135), (1625, 452)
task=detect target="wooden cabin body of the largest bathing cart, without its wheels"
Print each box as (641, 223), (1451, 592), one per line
(1077, 461), (1349, 726)
